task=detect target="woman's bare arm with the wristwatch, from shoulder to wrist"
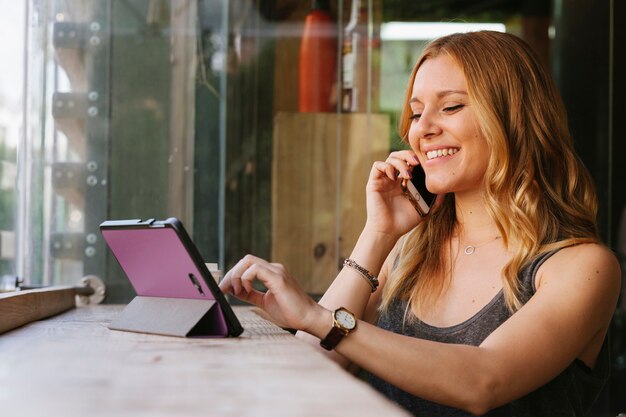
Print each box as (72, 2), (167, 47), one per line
(302, 245), (620, 414)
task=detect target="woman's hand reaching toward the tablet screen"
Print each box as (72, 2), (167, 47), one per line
(220, 255), (331, 336)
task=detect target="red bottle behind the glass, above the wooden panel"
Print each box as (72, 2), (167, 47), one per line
(299, 0), (337, 112)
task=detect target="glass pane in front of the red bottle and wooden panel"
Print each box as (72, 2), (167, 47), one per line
(216, 1), (390, 294)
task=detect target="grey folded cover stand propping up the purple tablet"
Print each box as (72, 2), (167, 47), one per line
(109, 296), (228, 337)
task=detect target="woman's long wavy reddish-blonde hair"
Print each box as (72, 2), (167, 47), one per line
(381, 31), (598, 317)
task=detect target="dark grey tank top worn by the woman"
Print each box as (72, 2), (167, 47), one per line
(368, 252), (610, 417)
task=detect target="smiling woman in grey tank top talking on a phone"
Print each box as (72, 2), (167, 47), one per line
(221, 32), (620, 417)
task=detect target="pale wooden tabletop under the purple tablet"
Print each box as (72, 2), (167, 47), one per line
(0, 306), (407, 417)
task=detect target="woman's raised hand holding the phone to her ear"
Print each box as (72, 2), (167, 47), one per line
(366, 150), (432, 236)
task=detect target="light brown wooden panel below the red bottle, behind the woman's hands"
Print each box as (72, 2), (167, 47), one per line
(272, 113), (389, 294)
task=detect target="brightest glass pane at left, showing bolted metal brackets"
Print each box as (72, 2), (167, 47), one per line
(19, 1), (110, 285)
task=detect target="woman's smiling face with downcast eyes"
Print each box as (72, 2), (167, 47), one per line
(408, 54), (490, 194)
